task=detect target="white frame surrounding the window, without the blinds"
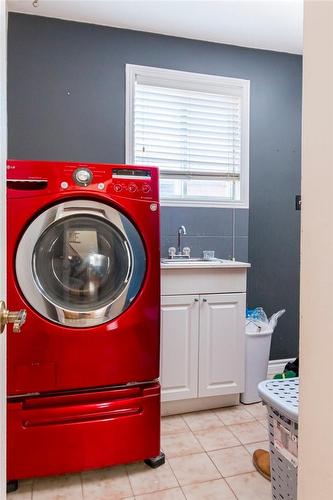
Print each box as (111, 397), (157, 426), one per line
(125, 64), (250, 208)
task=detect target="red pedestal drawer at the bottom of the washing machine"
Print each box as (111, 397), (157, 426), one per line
(7, 383), (160, 480)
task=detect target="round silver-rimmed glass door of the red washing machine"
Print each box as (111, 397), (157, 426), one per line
(16, 200), (146, 328)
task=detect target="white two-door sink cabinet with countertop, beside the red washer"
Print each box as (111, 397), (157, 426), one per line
(161, 261), (249, 414)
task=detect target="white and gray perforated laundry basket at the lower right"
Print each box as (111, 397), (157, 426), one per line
(258, 377), (299, 500)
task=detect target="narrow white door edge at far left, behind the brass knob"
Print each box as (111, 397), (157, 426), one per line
(0, 2), (7, 498)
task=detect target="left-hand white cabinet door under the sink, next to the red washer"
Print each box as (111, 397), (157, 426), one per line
(161, 295), (199, 401)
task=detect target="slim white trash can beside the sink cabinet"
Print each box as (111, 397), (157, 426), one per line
(240, 320), (274, 404)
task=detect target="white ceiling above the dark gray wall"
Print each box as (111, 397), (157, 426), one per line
(7, 0), (303, 54)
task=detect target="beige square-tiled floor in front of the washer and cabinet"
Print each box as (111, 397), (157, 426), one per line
(7, 403), (271, 500)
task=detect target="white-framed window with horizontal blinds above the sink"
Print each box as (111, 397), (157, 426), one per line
(126, 65), (250, 207)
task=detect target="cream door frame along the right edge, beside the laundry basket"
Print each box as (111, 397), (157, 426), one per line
(298, 1), (333, 500)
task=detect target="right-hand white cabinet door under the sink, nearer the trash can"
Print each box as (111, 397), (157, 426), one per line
(199, 293), (245, 396)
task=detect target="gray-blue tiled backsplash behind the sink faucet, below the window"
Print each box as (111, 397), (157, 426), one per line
(161, 207), (249, 261)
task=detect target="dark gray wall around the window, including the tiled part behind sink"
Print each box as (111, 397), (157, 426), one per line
(8, 14), (301, 359)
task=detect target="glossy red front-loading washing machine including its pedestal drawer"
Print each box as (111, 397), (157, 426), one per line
(7, 160), (164, 488)
